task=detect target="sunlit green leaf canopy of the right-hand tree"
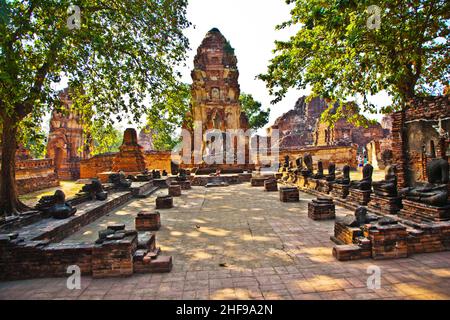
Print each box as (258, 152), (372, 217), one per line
(259, 0), (450, 112)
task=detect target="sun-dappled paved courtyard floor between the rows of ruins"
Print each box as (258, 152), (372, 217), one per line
(0, 184), (450, 299)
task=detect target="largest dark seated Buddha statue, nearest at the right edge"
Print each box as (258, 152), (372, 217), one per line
(400, 159), (449, 207)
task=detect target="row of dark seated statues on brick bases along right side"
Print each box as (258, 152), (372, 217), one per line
(279, 154), (450, 221)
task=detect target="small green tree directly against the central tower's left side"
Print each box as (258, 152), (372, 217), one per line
(145, 84), (191, 150)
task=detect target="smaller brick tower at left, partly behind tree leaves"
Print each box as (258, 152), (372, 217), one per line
(47, 88), (90, 180)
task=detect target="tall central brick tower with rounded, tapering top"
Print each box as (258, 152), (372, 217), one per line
(182, 28), (252, 174)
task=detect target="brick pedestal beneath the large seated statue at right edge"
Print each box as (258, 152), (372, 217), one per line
(399, 200), (450, 222)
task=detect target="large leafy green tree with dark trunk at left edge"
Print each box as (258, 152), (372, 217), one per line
(0, 0), (190, 215)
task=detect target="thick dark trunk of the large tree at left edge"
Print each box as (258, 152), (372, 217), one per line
(0, 116), (27, 219)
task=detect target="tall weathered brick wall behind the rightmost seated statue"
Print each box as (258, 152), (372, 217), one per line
(392, 96), (450, 187)
